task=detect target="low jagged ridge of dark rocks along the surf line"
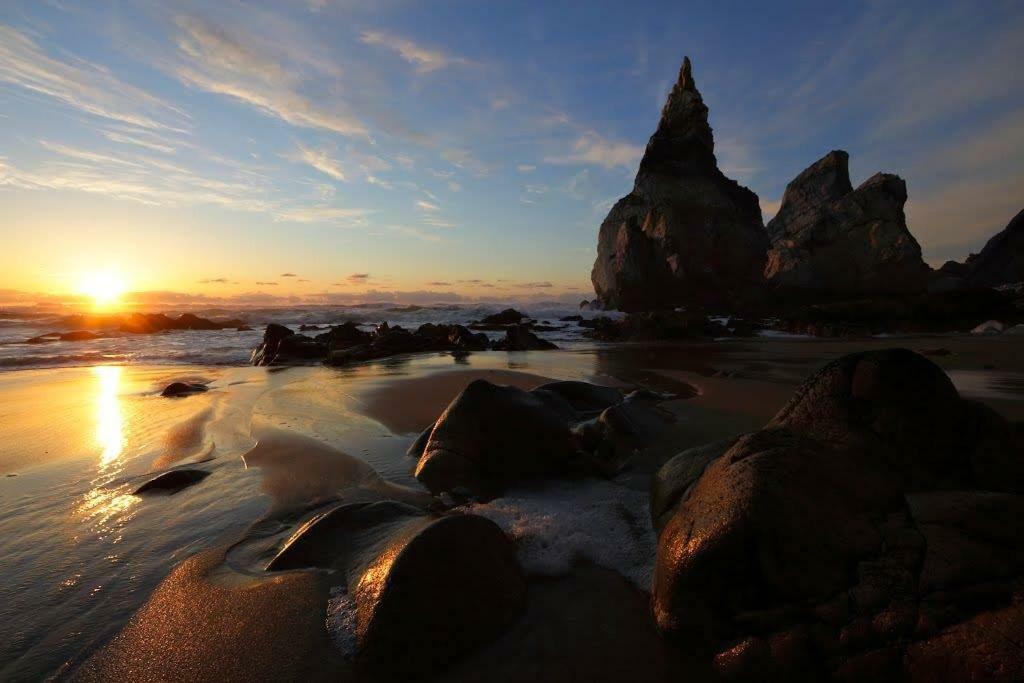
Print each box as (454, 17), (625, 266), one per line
(250, 323), (558, 366)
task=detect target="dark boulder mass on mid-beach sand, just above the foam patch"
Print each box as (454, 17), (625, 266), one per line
(410, 380), (669, 500)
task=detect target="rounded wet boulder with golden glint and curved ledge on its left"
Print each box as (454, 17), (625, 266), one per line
(267, 501), (526, 679)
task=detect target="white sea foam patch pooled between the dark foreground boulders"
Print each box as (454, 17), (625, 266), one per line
(468, 479), (657, 591)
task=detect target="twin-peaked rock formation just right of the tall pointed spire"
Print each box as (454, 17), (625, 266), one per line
(765, 151), (931, 298)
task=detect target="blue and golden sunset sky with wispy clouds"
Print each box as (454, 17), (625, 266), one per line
(0, 0), (1024, 303)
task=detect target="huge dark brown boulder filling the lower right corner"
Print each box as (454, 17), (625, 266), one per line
(651, 349), (1024, 680)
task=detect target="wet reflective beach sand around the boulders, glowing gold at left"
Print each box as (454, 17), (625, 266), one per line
(0, 337), (1024, 681)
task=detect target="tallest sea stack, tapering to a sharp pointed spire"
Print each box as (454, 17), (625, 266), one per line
(591, 57), (767, 311)
